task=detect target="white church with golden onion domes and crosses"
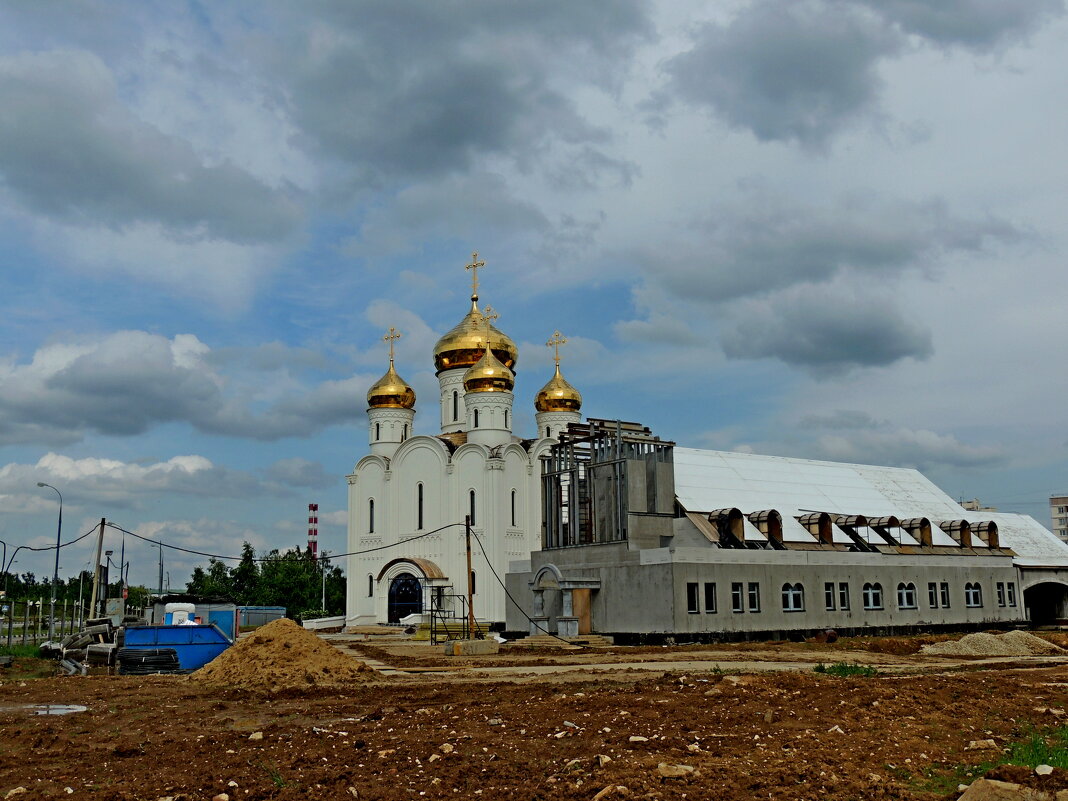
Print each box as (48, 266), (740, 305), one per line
(346, 253), (582, 626)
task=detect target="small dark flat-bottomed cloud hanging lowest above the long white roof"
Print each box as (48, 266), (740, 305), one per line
(722, 287), (933, 376)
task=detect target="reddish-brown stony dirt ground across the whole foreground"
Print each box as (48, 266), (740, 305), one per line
(0, 638), (1068, 801)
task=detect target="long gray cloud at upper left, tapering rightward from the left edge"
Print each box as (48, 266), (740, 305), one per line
(0, 51), (299, 242)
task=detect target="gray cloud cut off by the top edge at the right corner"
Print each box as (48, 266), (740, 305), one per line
(857, 0), (1064, 50)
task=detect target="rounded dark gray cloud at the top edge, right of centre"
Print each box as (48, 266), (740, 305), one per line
(666, 0), (901, 146)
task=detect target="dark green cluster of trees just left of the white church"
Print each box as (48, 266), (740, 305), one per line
(186, 543), (345, 617)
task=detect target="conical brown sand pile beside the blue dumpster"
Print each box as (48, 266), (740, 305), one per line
(191, 617), (374, 692)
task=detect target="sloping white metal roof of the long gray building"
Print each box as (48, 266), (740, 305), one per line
(675, 447), (1068, 566)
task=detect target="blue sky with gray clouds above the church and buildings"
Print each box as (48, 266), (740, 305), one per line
(0, 0), (1068, 588)
